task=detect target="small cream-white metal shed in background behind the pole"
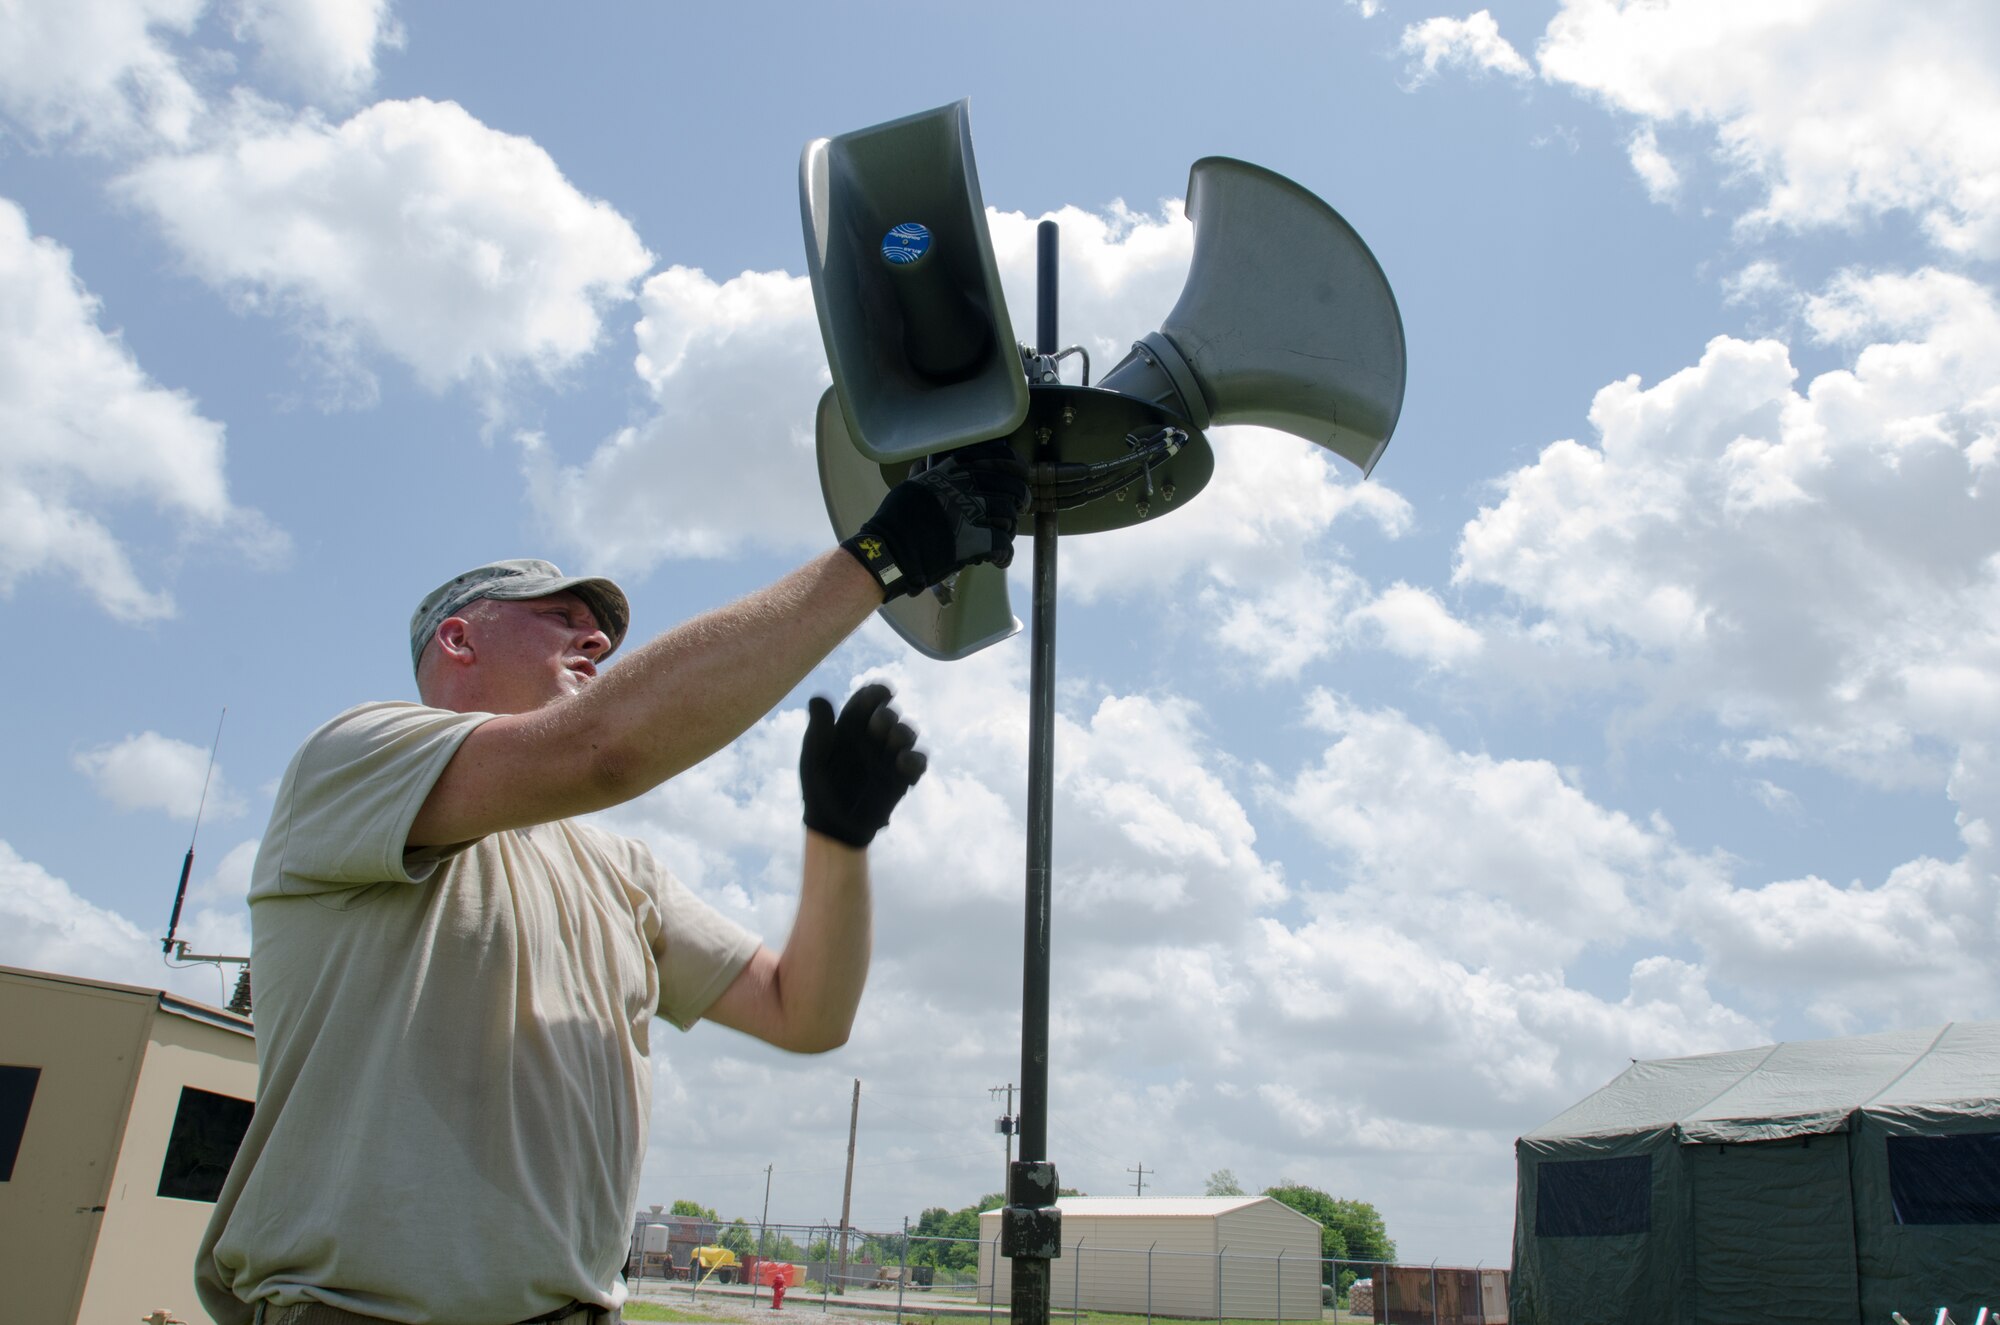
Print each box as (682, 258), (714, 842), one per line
(980, 1197), (1320, 1321)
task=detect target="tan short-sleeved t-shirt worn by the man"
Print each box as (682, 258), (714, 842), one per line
(196, 703), (758, 1325)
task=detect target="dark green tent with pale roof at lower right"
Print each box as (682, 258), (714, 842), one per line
(1512, 1021), (2000, 1325)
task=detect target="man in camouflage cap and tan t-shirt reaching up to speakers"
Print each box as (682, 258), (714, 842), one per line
(196, 442), (1028, 1325)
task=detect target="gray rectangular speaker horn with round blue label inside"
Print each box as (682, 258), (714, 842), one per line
(798, 100), (1028, 464)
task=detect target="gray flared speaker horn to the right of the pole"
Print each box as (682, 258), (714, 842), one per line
(1098, 156), (1406, 474)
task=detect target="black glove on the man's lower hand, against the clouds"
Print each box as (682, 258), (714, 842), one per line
(798, 685), (930, 847)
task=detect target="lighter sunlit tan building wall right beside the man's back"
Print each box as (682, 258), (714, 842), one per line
(76, 1009), (256, 1325)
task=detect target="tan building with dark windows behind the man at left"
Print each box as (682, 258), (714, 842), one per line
(0, 967), (256, 1325)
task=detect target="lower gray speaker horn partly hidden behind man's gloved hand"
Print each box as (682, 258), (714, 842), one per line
(814, 390), (1020, 663)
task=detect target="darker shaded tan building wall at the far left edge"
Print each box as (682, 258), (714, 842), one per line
(0, 971), (152, 1325)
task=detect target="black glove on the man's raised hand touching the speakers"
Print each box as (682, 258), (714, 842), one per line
(840, 438), (1028, 598)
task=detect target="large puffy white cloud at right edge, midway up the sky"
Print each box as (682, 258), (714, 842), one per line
(1454, 270), (2000, 783)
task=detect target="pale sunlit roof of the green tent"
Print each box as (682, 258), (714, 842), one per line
(1522, 1021), (2000, 1141)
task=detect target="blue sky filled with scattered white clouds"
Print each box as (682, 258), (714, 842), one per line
(0, 0), (2000, 1263)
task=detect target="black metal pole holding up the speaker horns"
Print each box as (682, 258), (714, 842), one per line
(1004, 220), (1062, 1325)
